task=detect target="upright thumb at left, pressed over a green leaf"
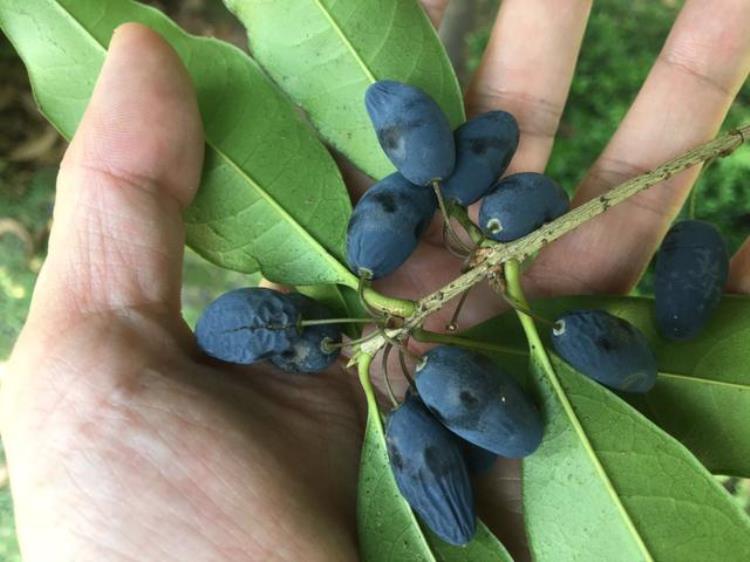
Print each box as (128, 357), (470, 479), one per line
(31, 24), (204, 319)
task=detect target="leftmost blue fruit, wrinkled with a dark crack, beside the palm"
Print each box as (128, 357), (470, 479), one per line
(195, 287), (299, 365)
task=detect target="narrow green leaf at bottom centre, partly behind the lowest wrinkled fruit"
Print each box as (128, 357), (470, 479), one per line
(357, 376), (512, 562)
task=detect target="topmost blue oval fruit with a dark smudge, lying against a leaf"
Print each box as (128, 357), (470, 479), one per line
(365, 80), (456, 185)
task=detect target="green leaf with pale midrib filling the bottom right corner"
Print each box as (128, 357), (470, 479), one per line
(523, 359), (750, 562)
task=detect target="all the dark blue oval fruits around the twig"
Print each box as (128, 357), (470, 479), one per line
(196, 81), (729, 545)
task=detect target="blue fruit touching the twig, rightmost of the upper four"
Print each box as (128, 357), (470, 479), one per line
(479, 172), (570, 242)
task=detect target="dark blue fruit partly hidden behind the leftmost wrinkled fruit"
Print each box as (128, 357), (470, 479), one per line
(269, 293), (341, 373)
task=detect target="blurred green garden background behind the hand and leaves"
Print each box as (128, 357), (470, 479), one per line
(0, 0), (750, 562)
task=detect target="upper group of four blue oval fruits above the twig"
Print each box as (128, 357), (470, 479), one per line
(347, 80), (569, 279)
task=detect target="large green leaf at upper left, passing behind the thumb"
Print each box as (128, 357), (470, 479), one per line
(0, 0), (356, 287)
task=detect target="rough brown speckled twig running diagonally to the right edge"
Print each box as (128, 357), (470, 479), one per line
(361, 124), (750, 355)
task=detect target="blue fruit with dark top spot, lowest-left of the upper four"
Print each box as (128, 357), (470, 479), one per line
(346, 172), (437, 279)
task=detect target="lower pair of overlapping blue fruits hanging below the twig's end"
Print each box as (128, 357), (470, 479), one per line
(386, 346), (543, 545)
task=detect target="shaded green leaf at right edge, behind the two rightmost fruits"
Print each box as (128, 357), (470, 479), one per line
(466, 295), (750, 477)
